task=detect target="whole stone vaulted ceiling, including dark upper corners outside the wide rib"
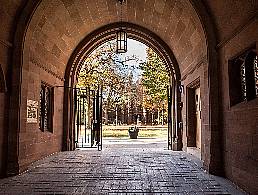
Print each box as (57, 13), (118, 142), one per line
(0, 0), (258, 77)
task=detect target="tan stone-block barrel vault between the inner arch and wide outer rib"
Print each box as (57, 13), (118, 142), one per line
(25, 0), (206, 79)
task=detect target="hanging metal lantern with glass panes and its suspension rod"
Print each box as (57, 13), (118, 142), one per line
(116, 0), (127, 53)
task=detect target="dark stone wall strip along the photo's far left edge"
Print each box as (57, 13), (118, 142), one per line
(0, 0), (22, 177)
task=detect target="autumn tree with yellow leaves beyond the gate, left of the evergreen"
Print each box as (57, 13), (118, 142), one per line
(77, 41), (138, 123)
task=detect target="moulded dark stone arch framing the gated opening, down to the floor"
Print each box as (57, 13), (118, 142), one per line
(63, 23), (182, 150)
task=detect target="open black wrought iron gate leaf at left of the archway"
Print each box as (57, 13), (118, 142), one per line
(74, 87), (102, 150)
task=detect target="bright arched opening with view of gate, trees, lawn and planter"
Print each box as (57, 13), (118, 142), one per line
(70, 37), (176, 149)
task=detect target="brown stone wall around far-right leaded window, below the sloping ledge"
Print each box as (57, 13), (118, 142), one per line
(219, 20), (258, 192)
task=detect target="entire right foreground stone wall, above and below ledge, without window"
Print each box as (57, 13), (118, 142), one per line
(208, 0), (258, 194)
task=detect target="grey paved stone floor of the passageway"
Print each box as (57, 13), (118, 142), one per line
(0, 141), (246, 194)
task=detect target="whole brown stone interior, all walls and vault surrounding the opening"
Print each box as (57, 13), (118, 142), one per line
(0, 0), (258, 192)
